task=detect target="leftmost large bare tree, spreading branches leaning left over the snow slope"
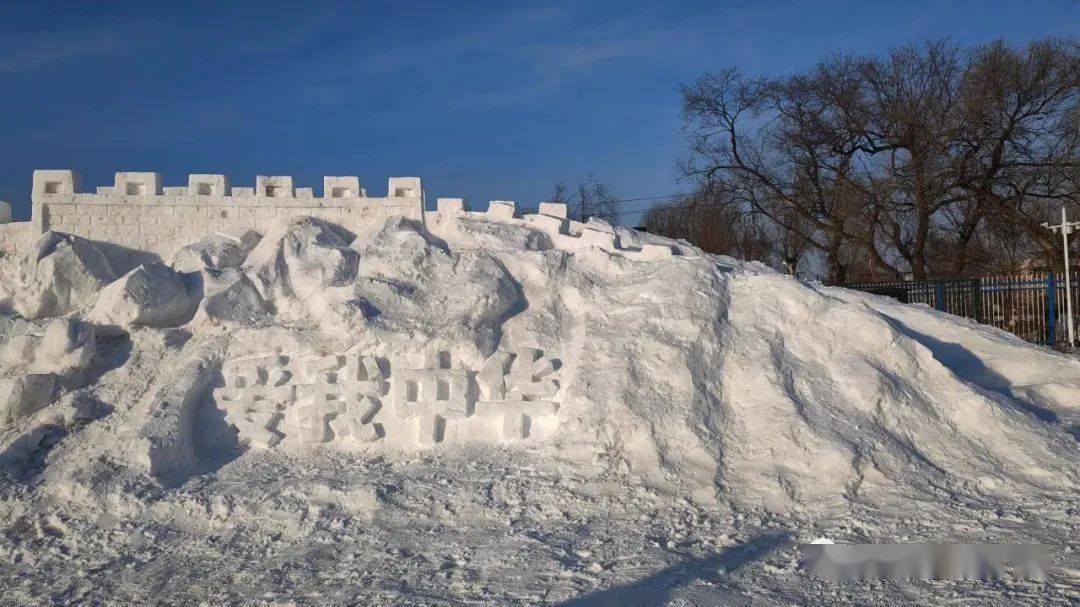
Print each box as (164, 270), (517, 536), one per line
(683, 58), (900, 282)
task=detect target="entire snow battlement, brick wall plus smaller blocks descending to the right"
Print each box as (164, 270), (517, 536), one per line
(23, 171), (678, 261)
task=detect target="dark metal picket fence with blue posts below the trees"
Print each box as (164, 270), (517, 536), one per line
(843, 272), (1080, 346)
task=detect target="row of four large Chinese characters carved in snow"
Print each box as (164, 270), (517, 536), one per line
(214, 348), (559, 448)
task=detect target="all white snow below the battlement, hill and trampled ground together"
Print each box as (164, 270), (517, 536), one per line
(0, 214), (1080, 605)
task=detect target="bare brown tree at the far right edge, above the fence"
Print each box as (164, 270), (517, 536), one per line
(958, 39), (1080, 258)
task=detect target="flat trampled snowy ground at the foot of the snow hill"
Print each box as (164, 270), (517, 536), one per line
(0, 450), (1080, 606)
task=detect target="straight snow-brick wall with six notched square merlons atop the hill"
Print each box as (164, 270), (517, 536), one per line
(31, 171), (424, 259)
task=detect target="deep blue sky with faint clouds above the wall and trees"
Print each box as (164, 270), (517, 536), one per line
(0, 0), (1080, 224)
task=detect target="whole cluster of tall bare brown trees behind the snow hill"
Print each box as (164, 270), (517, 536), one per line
(683, 39), (1080, 282)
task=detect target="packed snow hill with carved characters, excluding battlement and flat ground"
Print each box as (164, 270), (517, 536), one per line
(0, 209), (1080, 600)
